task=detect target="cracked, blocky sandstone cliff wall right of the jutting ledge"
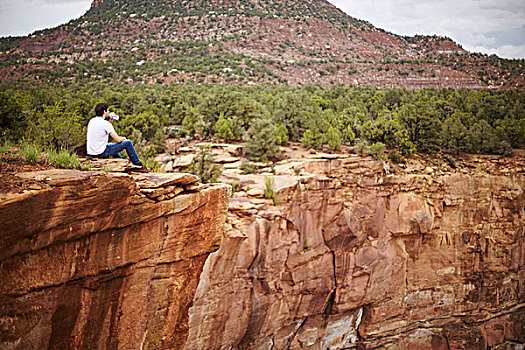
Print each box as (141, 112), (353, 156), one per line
(185, 157), (525, 349)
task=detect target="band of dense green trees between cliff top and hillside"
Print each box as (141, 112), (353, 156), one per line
(0, 82), (525, 165)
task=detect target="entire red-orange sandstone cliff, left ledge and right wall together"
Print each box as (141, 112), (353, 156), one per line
(0, 154), (525, 349)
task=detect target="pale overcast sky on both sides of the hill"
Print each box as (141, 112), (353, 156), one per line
(0, 0), (525, 58)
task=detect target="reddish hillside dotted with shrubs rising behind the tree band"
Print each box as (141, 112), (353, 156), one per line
(0, 0), (525, 89)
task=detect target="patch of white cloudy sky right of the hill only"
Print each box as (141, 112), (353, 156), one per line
(330, 0), (525, 58)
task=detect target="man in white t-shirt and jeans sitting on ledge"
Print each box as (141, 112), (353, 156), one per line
(86, 103), (149, 172)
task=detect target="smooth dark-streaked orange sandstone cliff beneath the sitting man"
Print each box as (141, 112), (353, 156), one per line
(0, 170), (229, 349)
